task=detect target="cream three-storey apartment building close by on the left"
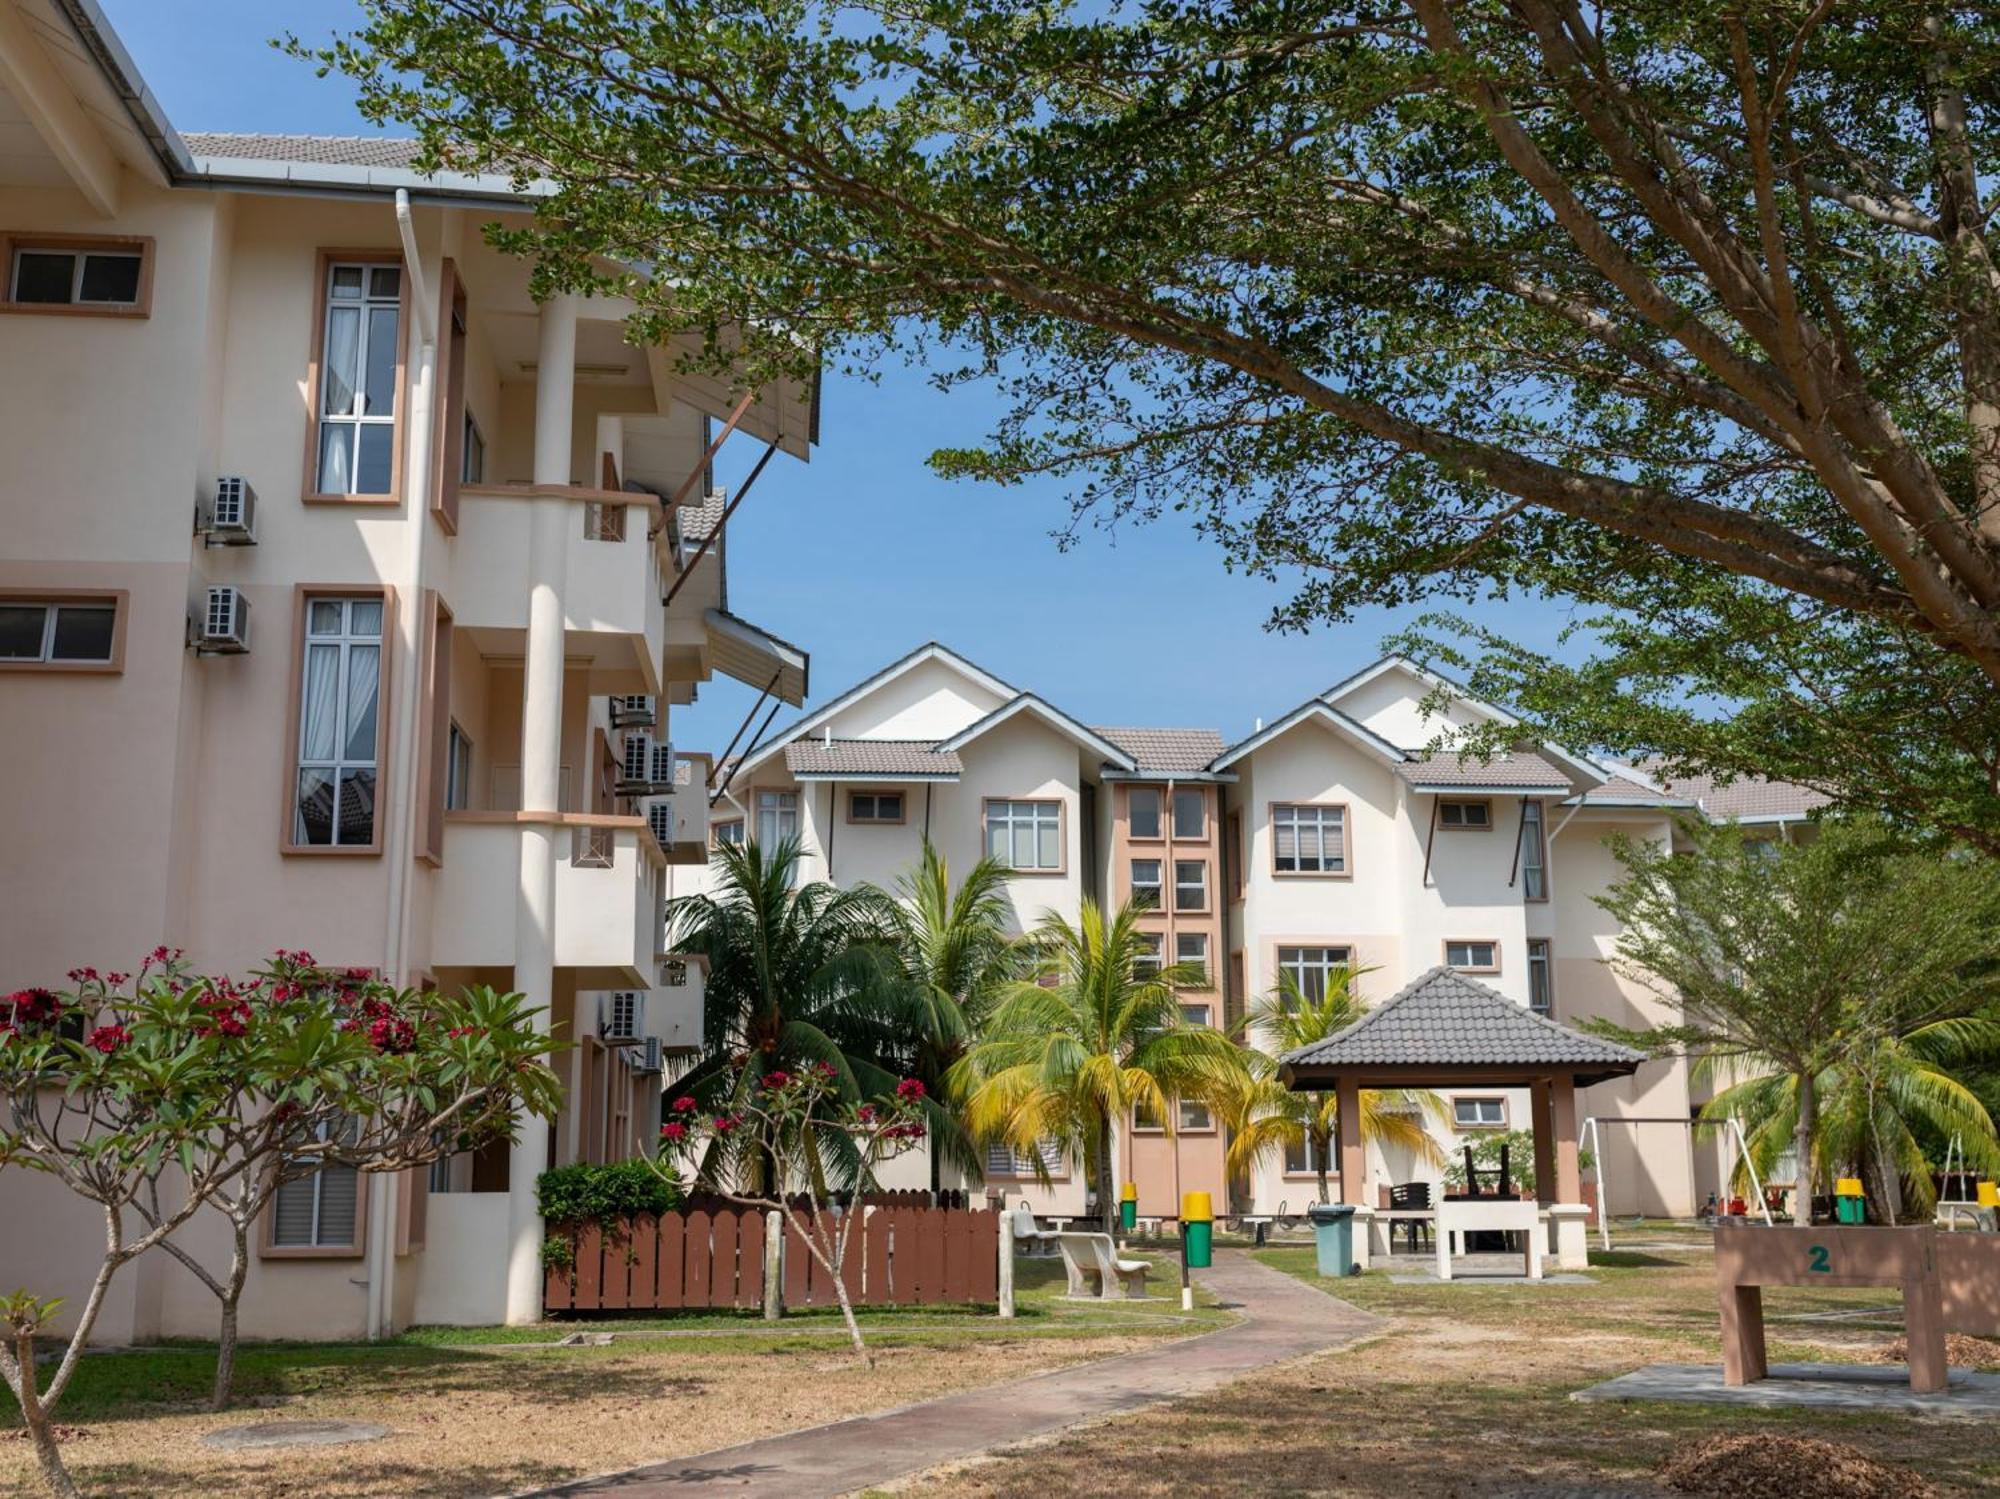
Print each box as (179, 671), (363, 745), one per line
(0, 0), (816, 1341)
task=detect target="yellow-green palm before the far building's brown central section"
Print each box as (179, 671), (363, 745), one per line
(950, 899), (1244, 1233)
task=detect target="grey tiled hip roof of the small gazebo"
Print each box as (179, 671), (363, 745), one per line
(1280, 967), (1644, 1077)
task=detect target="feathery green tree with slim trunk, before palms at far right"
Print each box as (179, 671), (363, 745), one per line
(1598, 821), (2000, 1223)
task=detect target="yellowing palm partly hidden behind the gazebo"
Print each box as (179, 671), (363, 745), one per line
(1222, 967), (1446, 1203)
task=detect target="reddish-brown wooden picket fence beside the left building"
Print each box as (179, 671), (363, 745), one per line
(542, 1193), (1000, 1311)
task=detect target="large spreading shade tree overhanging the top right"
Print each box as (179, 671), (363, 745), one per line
(316, 0), (2000, 851)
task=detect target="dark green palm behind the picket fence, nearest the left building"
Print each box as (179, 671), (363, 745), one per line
(666, 839), (924, 1191)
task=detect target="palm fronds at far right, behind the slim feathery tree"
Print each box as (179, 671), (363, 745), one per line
(1694, 1015), (2000, 1221)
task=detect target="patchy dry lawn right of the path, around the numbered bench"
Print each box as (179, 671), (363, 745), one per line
(898, 1247), (2000, 1499)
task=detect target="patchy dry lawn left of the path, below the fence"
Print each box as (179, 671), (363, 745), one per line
(0, 1259), (1228, 1499)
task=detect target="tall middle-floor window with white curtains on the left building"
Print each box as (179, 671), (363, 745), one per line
(292, 598), (384, 847)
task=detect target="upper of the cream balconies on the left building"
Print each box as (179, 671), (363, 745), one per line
(444, 484), (666, 692)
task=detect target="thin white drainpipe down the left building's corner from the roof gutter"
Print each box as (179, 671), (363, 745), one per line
(366, 188), (438, 1339)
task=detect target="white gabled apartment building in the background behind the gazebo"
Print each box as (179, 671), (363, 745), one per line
(692, 644), (1816, 1215)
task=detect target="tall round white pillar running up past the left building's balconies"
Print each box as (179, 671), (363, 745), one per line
(506, 296), (576, 1325)
